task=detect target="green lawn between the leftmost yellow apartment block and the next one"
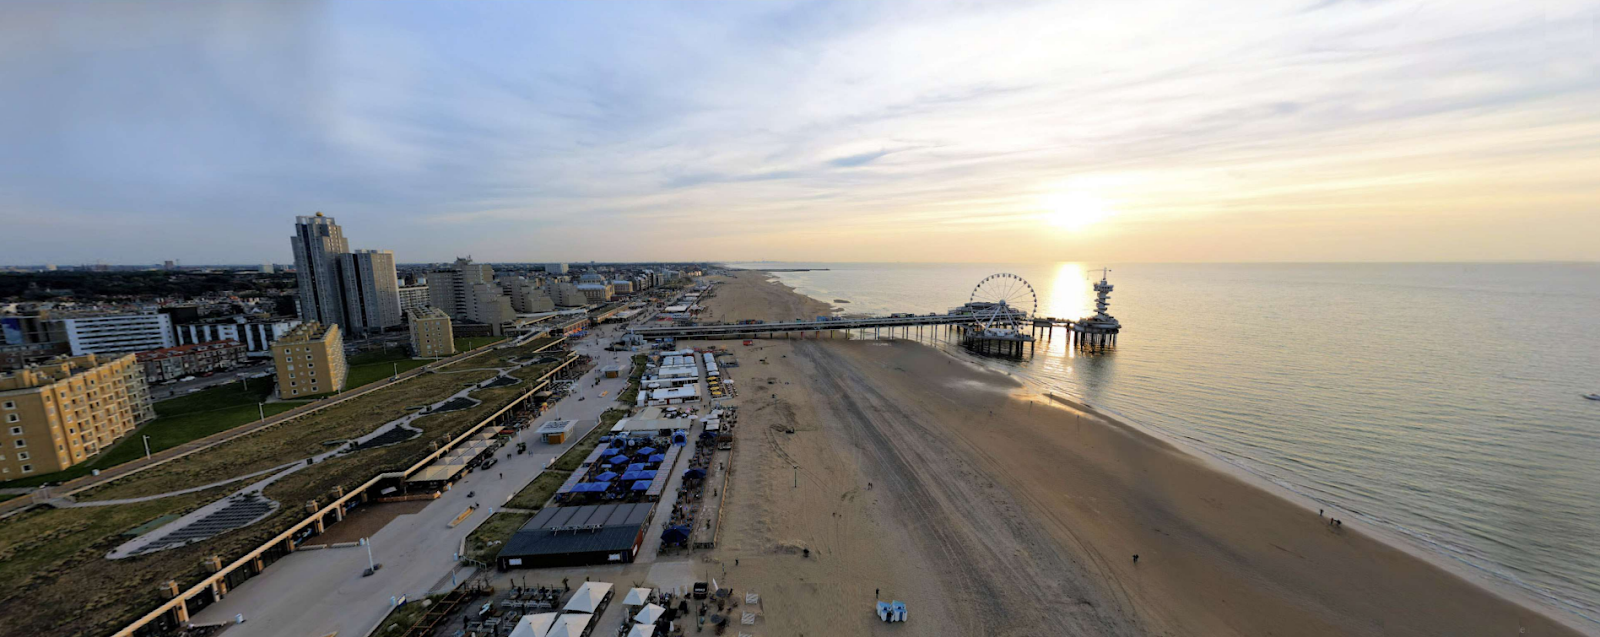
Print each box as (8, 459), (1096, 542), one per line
(0, 378), (301, 488)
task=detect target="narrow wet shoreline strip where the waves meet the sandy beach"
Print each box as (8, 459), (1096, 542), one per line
(723, 272), (1595, 634)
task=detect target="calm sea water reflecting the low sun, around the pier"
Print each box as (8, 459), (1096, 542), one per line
(733, 262), (1600, 627)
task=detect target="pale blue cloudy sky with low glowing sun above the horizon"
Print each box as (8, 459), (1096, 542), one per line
(0, 0), (1600, 264)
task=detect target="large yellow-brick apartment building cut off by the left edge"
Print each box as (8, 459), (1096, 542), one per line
(0, 354), (155, 480)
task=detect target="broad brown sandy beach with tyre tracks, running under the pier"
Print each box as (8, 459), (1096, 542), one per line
(694, 272), (1579, 635)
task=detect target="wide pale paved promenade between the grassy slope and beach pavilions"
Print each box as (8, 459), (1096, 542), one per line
(194, 328), (627, 637)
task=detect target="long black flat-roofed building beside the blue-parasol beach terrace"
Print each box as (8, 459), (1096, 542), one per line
(494, 503), (654, 570)
